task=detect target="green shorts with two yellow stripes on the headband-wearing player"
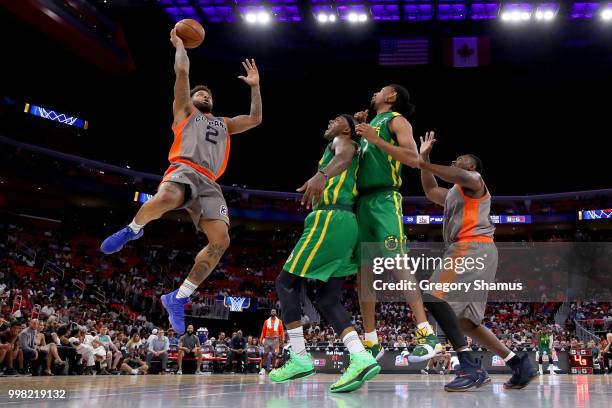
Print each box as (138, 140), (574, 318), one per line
(283, 210), (358, 282)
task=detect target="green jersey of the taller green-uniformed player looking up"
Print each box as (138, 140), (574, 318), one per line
(357, 112), (402, 192)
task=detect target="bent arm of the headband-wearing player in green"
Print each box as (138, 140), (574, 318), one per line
(297, 138), (357, 208)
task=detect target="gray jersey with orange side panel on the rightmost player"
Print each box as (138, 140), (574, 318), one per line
(443, 184), (495, 244)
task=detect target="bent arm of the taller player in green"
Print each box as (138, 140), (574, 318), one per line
(356, 116), (419, 167)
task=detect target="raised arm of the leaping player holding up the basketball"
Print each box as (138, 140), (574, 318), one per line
(170, 28), (193, 124)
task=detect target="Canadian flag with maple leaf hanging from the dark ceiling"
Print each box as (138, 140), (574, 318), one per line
(444, 37), (490, 68)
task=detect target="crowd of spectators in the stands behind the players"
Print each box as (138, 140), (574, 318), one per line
(0, 207), (612, 375)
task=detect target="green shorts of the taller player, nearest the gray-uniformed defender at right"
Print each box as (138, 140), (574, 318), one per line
(355, 189), (406, 259)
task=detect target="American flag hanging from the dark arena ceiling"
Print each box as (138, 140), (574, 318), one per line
(378, 38), (429, 66)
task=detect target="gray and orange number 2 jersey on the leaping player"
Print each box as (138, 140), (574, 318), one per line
(168, 109), (230, 181)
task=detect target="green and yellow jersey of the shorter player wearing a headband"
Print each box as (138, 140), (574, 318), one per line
(313, 143), (359, 210)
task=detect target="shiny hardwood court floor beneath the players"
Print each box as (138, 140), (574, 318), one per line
(0, 374), (612, 408)
